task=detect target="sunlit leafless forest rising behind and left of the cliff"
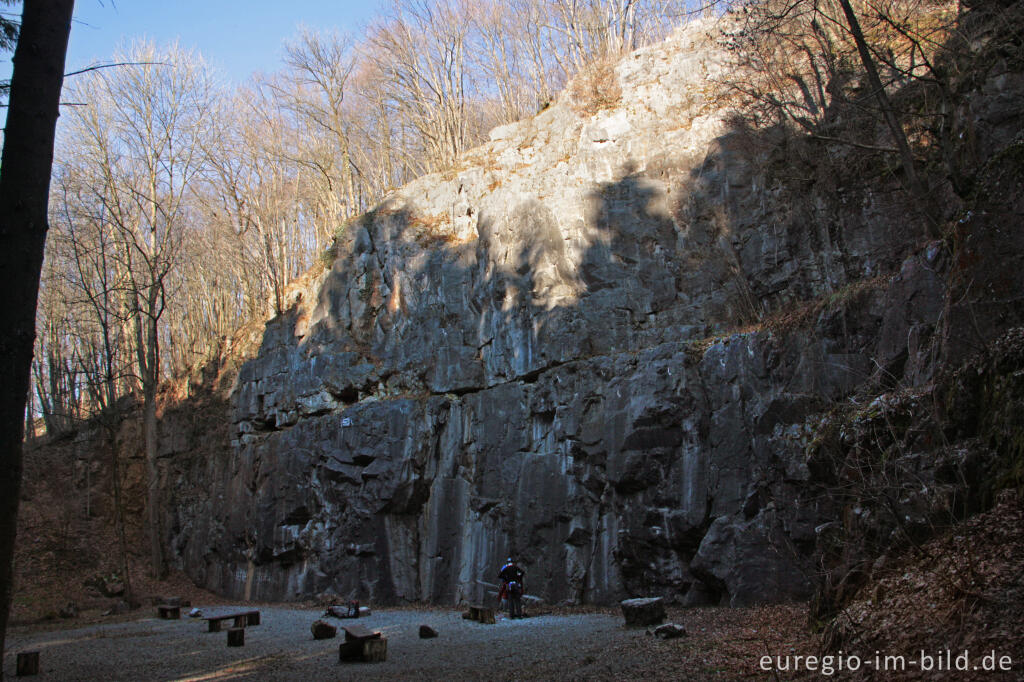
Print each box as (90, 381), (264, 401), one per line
(28, 0), (699, 434)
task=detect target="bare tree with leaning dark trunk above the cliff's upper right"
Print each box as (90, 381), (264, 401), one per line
(728, 0), (954, 235)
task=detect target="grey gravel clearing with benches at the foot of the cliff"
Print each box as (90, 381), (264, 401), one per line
(3, 606), (630, 681)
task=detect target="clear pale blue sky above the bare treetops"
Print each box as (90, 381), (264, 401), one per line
(7, 0), (385, 83)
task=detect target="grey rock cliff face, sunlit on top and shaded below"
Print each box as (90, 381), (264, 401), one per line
(165, 15), (1020, 604)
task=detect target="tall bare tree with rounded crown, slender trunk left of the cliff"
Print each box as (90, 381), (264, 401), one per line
(62, 43), (216, 577)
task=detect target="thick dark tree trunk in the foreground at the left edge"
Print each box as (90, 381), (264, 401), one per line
(0, 0), (75, 667)
